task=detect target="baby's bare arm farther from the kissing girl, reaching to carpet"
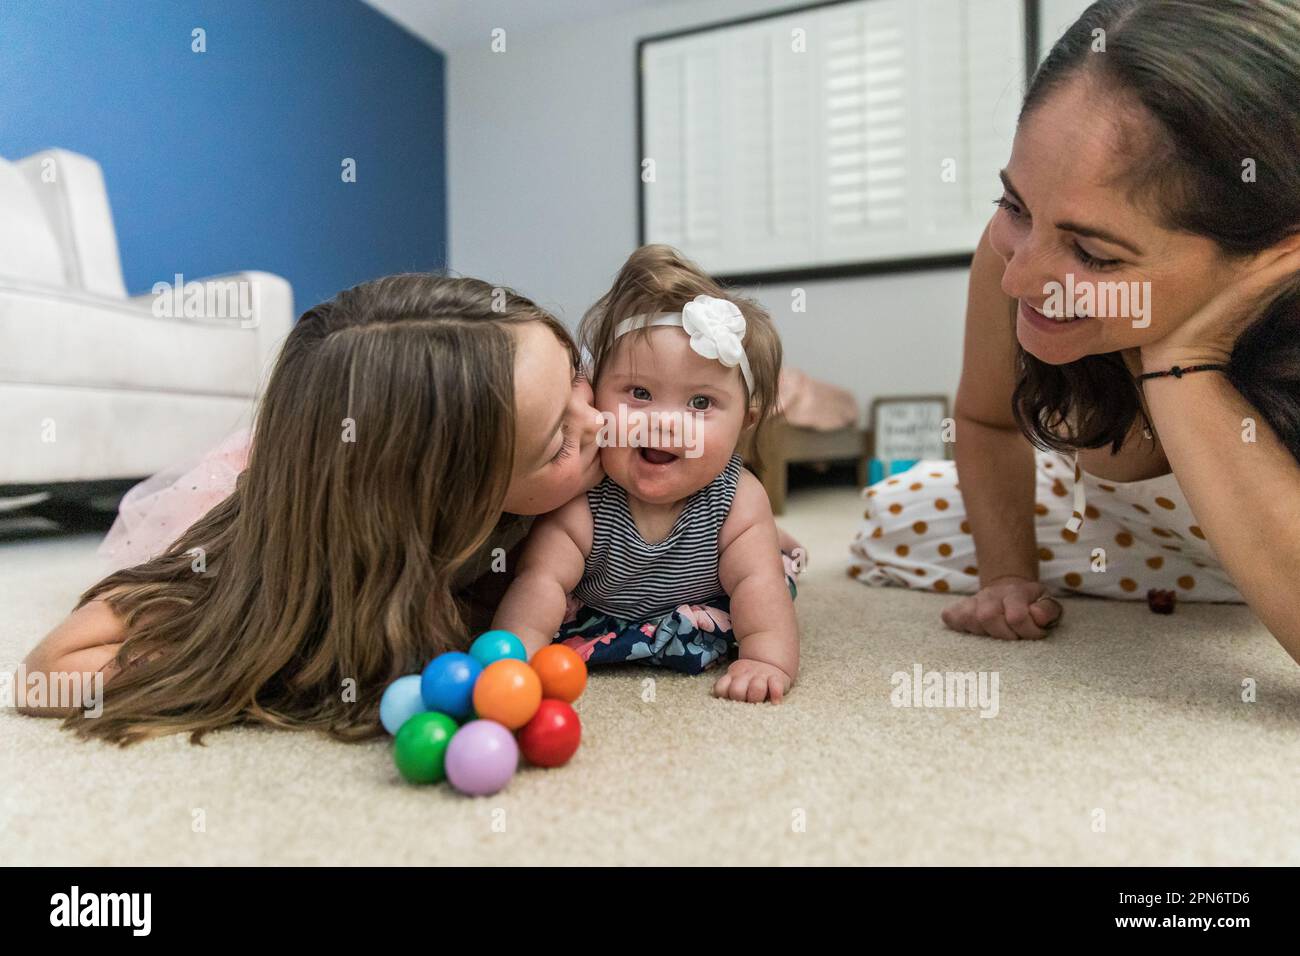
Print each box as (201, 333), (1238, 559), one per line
(719, 471), (800, 700)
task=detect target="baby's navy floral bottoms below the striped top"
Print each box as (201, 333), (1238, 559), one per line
(553, 554), (800, 674)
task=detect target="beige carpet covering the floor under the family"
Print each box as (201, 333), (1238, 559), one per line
(0, 490), (1300, 865)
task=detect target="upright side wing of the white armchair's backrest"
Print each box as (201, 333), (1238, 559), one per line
(14, 150), (126, 299)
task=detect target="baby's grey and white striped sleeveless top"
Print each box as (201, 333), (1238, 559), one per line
(573, 455), (742, 620)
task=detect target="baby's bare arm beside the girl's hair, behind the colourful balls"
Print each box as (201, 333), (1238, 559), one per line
(493, 494), (592, 657)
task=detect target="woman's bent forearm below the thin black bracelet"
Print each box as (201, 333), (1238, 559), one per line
(1144, 365), (1300, 663)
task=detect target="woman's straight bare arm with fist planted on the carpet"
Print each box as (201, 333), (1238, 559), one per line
(944, 229), (1061, 640)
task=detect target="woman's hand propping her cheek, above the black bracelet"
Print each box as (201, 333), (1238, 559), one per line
(1140, 243), (1300, 372)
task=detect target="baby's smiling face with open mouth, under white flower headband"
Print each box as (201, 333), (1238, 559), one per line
(595, 326), (751, 505)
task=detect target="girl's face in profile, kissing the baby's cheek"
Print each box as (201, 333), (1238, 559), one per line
(502, 323), (603, 515)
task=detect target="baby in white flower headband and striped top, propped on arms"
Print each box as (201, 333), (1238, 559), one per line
(494, 246), (798, 702)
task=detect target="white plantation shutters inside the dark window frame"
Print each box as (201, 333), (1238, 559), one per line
(642, 0), (1024, 274)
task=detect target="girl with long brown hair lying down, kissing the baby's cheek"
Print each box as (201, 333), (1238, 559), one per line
(25, 274), (601, 743)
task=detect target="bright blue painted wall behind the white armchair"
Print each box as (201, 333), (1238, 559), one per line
(0, 0), (447, 313)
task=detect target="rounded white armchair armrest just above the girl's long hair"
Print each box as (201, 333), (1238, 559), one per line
(129, 272), (294, 382)
